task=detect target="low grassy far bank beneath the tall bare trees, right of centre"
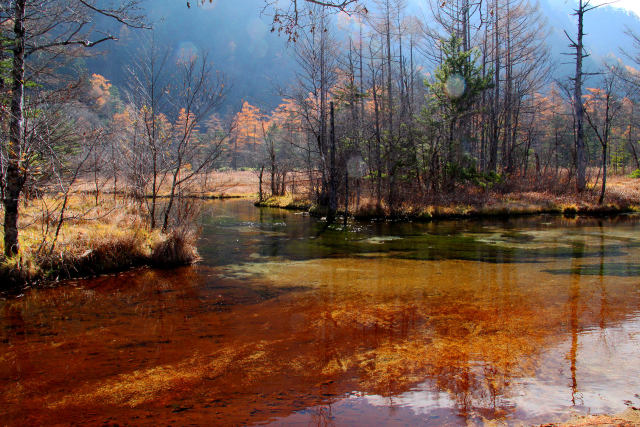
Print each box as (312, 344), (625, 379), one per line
(256, 177), (640, 221)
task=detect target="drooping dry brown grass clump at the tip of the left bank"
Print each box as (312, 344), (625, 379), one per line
(151, 227), (198, 267)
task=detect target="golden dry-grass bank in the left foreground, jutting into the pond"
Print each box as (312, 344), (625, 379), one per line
(0, 194), (197, 288)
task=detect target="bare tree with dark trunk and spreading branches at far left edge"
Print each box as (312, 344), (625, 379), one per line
(0, 0), (143, 256)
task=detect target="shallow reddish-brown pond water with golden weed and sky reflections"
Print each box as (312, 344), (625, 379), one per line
(0, 200), (640, 425)
